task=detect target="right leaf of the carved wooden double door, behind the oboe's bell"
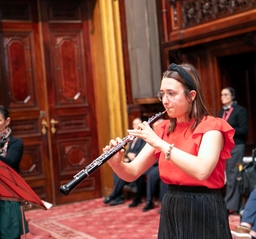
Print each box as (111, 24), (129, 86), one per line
(40, 1), (101, 204)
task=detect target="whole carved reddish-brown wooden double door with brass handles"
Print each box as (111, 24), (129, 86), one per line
(0, 0), (101, 205)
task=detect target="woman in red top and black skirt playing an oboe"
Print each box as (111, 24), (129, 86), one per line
(103, 63), (234, 239)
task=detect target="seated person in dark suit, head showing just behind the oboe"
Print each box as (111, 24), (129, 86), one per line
(103, 118), (145, 207)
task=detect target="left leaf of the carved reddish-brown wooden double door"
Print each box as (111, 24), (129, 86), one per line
(0, 1), (53, 202)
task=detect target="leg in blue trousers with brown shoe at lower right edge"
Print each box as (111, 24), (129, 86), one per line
(231, 188), (256, 239)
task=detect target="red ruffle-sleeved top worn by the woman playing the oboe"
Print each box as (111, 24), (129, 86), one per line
(154, 116), (235, 188)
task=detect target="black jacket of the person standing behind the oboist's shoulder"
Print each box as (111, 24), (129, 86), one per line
(218, 105), (248, 145)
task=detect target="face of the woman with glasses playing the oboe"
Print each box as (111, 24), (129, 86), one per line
(160, 78), (196, 122)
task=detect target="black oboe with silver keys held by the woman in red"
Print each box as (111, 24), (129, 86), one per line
(60, 111), (166, 196)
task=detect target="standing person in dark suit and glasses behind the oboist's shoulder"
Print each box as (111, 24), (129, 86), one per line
(218, 87), (248, 214)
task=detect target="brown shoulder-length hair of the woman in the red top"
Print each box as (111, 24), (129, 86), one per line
(163, 63), (209, 133)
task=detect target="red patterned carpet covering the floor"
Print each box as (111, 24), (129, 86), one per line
(22, 198), (239, 239)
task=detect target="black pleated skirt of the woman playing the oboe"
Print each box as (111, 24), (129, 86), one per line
(158, 185), (232, 239)
